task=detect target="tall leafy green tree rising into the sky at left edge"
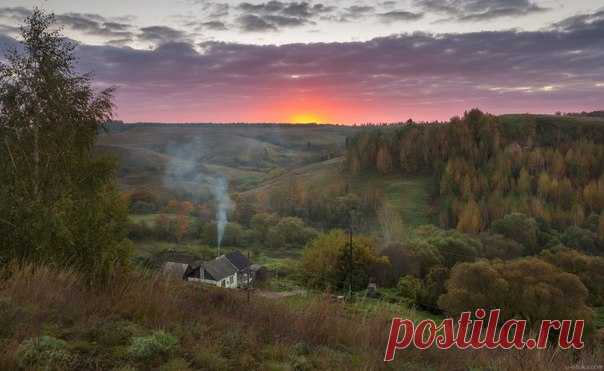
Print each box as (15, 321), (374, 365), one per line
(0, 9), (130, 280)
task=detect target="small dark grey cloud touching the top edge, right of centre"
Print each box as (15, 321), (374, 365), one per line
(415, 0), (548, 21)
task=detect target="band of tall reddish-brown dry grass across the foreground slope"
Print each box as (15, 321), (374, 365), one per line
(0, 265), (602, 370)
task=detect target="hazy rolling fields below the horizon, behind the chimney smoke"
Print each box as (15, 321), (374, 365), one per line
(97, 124), (360, 195)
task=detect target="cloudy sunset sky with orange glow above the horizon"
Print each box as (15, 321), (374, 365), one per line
(0, 0), (604, 124)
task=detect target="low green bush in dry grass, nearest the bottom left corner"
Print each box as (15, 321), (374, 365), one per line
(16, 336), (72, 370)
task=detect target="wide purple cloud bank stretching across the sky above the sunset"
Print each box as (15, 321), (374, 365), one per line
(5, 8), (604, 120)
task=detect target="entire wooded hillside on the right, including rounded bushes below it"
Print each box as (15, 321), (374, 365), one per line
(345, 109), (604, 320)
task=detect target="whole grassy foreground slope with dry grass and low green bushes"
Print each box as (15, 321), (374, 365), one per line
(0, 266), (588, 371)
